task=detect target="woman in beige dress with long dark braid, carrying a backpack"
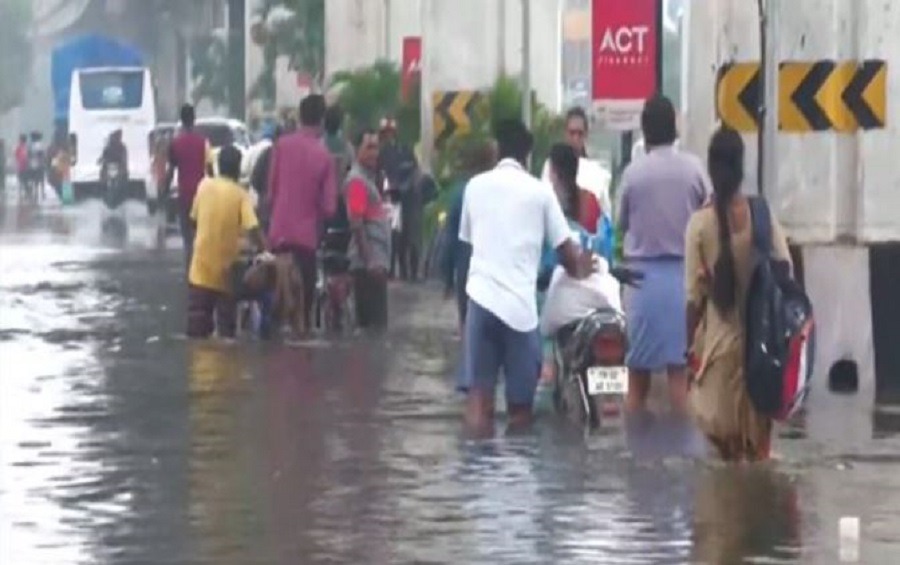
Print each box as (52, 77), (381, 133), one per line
(685, 127), (790, 461)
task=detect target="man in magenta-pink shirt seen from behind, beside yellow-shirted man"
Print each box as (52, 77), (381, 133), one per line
(268, 94), (338, 328)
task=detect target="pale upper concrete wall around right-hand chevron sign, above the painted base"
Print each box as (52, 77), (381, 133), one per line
(684, 0), (900, 244)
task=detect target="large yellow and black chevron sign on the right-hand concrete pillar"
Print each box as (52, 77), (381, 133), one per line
(716, 60), (887, 132)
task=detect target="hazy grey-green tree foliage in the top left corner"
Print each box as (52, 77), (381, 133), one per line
(0, 0), (33, 115)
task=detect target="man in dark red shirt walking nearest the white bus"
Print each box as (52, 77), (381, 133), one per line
(161, 104), (209, 266)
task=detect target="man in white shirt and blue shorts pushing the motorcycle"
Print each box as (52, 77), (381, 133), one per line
(459, 120), (592, 428)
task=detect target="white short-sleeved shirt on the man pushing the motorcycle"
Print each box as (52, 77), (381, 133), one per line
(459, 159), (571, 332)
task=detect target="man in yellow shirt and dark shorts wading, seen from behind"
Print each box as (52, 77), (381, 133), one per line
(187, 146), (266, 338)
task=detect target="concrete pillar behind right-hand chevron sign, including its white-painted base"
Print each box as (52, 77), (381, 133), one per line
(683, 0), (900, 426)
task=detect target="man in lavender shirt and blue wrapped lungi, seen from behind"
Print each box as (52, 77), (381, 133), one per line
(619, 96), (710, 410)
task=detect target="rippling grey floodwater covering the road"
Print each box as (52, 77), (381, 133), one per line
(0, 192), (900, 565)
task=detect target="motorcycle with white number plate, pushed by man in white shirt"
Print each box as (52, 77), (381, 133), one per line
(553, 268), (643, 428)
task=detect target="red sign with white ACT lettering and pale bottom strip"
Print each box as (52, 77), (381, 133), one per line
(591, 0), (658, 131)
